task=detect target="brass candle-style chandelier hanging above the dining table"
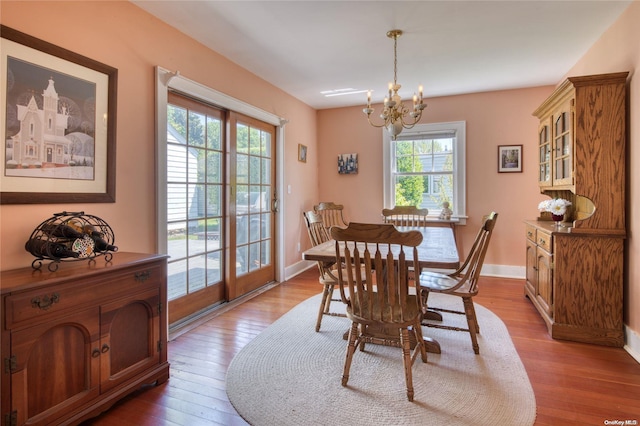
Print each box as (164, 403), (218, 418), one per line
(362, 30), (427, 140)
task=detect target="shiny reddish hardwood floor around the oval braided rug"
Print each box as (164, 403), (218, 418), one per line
(86, 268), (640, 426)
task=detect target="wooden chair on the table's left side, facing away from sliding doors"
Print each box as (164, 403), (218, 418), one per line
(302, 211), (346, 331)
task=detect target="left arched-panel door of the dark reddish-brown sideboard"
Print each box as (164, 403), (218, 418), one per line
(11, 307), (100, 425)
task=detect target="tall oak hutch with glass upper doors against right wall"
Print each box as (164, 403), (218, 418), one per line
(525, 72), (628, 346)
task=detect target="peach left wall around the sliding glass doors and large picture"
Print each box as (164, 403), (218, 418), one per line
(0, 0), (318, 270)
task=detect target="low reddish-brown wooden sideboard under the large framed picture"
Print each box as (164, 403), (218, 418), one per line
(0, 253), (169, 426)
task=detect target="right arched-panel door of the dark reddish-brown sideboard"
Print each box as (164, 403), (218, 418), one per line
(100, 288), (162, 392)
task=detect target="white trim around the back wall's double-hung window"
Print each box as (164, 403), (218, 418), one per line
(382, 121), (468, 225)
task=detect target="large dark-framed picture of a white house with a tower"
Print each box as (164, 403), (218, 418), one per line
(0, 25), (118, 204)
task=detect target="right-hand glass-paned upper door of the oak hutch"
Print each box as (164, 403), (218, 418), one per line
(552, 102), (574, 189)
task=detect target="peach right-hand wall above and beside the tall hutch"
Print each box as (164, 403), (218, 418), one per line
(567, 1), (640, 340)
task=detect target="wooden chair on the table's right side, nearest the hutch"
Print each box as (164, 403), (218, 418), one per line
(420, 212), (498, 354)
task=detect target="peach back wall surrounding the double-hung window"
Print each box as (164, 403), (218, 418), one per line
(318, 86), (553, 267)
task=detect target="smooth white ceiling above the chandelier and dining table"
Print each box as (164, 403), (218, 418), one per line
(131, 0), (631, 109)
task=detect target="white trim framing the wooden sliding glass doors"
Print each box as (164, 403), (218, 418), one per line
(156, 66), (288, 281)
